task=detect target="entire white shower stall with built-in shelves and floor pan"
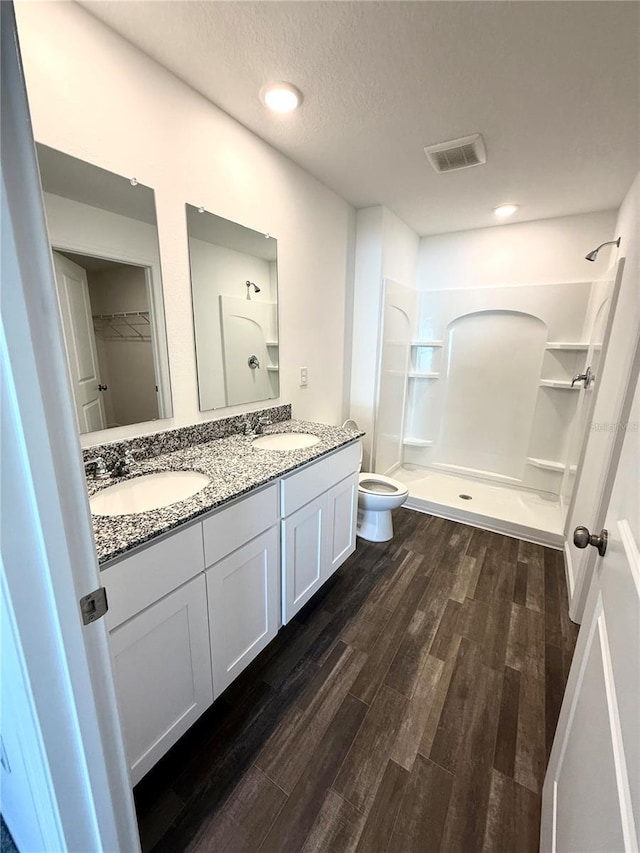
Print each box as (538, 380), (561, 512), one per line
(372, 280), (612, 546)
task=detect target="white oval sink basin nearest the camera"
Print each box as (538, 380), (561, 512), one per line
(89, 471), (211, 515)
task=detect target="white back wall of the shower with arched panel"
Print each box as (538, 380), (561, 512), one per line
(403, 282), (592, 494)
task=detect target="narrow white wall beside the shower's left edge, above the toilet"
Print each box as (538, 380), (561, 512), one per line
(349, 206), (419, 470)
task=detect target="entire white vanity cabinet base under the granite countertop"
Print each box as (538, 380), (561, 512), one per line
(102, 442), (360, 785)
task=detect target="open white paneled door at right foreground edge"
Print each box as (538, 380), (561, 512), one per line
(541, 336), (640, 853)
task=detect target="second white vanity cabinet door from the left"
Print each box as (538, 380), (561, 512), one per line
(205, 527), (280, 697)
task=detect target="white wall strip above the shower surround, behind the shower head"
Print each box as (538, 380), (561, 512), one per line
(416, 210), (616, 290)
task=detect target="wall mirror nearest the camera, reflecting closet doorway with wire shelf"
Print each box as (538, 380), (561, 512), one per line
(36, 144), (172, 433)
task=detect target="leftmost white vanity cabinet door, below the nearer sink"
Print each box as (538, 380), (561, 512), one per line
(110, 574), (213, 785)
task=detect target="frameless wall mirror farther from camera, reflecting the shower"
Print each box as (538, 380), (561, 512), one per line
(187, 204), (280, 412)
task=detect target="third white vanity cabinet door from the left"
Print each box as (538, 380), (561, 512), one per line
(282, 492), (327, 625)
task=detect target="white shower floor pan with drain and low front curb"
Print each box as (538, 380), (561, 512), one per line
(398, 468), (563, 548)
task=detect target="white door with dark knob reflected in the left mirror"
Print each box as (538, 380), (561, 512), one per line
(53, 252), (106, 433)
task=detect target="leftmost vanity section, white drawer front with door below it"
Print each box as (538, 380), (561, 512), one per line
(103, 525), (213, 785)
